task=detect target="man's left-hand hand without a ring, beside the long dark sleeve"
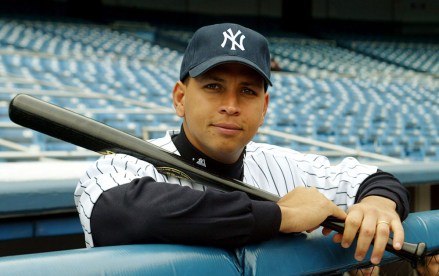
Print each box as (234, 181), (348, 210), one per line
(277, 187), (346, 233)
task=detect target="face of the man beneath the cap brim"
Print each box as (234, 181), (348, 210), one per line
(173, 63), (269, 164)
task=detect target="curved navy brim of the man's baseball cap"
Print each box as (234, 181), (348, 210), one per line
(189, 56), (273, 86)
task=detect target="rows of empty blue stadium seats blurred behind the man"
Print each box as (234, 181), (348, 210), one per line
(0, 19), (439, 161)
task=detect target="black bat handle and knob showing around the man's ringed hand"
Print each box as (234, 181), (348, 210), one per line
(321, 217), (427, 268)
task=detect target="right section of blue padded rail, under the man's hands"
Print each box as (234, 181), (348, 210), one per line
(240, 210), (439, 275)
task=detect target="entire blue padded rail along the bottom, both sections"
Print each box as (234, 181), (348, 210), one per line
(0, 210), (439, 275)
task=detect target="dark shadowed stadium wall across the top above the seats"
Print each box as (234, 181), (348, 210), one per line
(0, 0), (439, 34)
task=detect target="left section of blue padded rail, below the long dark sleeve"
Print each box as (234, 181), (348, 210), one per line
(0, 244), (241, 276)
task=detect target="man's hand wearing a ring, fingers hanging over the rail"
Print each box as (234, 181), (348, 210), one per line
(330, 196), (404, 264)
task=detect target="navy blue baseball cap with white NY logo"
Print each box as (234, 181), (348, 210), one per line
(180, 23), (272, 88)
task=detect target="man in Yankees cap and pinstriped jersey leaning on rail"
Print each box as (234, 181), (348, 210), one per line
(75, 23), (408, 264)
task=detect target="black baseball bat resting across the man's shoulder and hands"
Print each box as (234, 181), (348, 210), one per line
(9, 94), (425, 264)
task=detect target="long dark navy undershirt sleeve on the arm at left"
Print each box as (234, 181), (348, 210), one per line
(91, 177), (281, 247)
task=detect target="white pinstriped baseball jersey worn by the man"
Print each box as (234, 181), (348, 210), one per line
(75, 131), (377, 247)
